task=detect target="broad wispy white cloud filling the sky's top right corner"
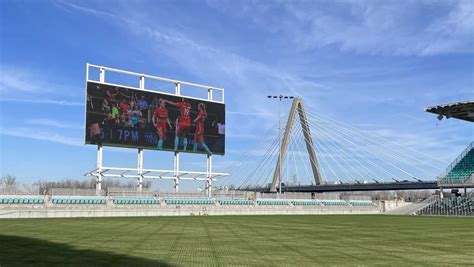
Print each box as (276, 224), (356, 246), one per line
(209, 0), (474, 56)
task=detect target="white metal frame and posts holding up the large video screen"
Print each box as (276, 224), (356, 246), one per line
(84, 63), (229, 197)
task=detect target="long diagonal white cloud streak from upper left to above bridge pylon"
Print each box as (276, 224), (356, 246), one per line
(54, 0), (330, 144)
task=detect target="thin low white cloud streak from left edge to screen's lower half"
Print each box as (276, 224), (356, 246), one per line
(0, 128), (84, 146)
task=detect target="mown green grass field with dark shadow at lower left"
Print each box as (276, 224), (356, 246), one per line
(0, 215), (474, 266)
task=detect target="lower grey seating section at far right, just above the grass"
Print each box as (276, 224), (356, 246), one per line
(417, 197), (474, 216)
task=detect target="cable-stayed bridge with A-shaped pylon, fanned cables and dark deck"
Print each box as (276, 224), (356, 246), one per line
(226, 98), (470, 192)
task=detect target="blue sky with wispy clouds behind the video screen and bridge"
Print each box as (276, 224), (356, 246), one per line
(0, 0), (474, 192)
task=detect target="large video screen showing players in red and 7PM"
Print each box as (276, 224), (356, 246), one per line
(85, 82), (225, 155)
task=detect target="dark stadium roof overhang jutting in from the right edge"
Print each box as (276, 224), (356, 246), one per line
(425, 100), (474, 122)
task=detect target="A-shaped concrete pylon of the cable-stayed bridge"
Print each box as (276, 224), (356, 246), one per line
(270, 97), (322, 192)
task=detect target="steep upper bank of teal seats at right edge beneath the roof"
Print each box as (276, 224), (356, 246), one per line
(441, 144), (474, 184)
